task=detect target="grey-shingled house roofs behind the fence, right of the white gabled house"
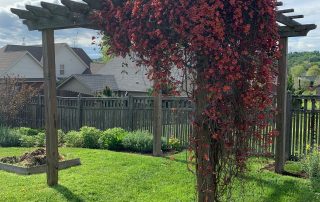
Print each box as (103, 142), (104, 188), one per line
(57, 57), (152, 97)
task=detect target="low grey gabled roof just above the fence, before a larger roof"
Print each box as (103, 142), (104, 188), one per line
(57, 74), (119, 97)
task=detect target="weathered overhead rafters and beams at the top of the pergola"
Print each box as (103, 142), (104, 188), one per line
(11, 0), (316, 37)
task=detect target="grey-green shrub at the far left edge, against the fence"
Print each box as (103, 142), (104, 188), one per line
(0, 126), (21, 147)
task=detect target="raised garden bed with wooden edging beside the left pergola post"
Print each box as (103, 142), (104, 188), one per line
(0, 149), (81, 175)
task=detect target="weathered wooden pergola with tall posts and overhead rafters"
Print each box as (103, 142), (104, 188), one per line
(11, 0), (316, 186)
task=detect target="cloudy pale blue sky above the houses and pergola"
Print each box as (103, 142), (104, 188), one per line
(0, 0), (320, 59)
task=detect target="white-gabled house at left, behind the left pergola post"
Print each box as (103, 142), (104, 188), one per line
(0, 43), (92, 82)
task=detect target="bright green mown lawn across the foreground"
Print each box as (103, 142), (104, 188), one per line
(0, 148), (320, 202)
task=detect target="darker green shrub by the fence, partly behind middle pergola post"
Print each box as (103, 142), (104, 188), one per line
(123, 130), (167, 153)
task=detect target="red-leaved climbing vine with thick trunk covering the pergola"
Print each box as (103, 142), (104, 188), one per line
(96, 0), (279, 201)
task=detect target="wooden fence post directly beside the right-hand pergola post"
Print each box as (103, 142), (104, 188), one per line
(285, 92), (292, 160)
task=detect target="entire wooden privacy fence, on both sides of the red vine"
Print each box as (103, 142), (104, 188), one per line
(3, 94), (320, 157)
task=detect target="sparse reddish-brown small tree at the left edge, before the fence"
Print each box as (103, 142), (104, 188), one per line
(0, 76), (37, 123)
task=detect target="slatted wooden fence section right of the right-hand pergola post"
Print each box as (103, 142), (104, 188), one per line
(287, 94), (320, 157)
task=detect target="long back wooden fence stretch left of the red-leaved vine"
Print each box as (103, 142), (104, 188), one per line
(9, 96), (193, 144)
